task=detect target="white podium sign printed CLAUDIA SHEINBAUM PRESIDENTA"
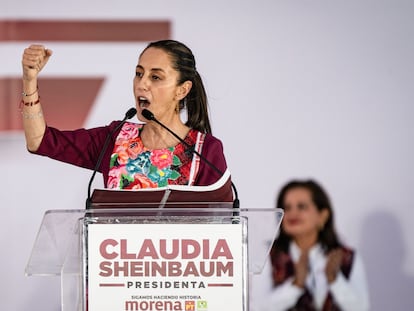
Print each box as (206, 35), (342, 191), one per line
(85, 223), (247, 311)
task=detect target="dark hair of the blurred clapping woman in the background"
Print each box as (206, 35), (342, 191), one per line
(273, 180), (342, 252)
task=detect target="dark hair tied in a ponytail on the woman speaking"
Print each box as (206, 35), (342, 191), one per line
(143, 40), (211, 133)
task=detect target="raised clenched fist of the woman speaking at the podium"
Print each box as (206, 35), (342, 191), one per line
(22, 44), (52, 81)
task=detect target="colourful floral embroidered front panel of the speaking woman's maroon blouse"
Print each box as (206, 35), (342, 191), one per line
(107, 122), (205, 189)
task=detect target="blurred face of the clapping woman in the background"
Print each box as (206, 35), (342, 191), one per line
(282, 187), (328, 242)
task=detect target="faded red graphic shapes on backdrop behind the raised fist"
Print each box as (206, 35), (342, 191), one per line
(0, 20), (171, 131)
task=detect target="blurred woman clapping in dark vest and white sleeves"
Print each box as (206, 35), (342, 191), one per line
(255, 180), (369, 311)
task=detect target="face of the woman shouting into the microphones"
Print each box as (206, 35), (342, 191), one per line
(134, 48), (186, 121)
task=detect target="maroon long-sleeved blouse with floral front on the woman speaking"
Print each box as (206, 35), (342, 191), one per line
(32, 121), (231, 192)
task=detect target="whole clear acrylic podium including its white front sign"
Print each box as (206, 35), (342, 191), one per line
(26, 207), (283, 311)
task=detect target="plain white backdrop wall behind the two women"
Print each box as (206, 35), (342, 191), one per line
(0, 0), (414, 311)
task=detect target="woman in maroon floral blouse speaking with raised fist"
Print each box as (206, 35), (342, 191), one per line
(20, 40), (232, 197)
